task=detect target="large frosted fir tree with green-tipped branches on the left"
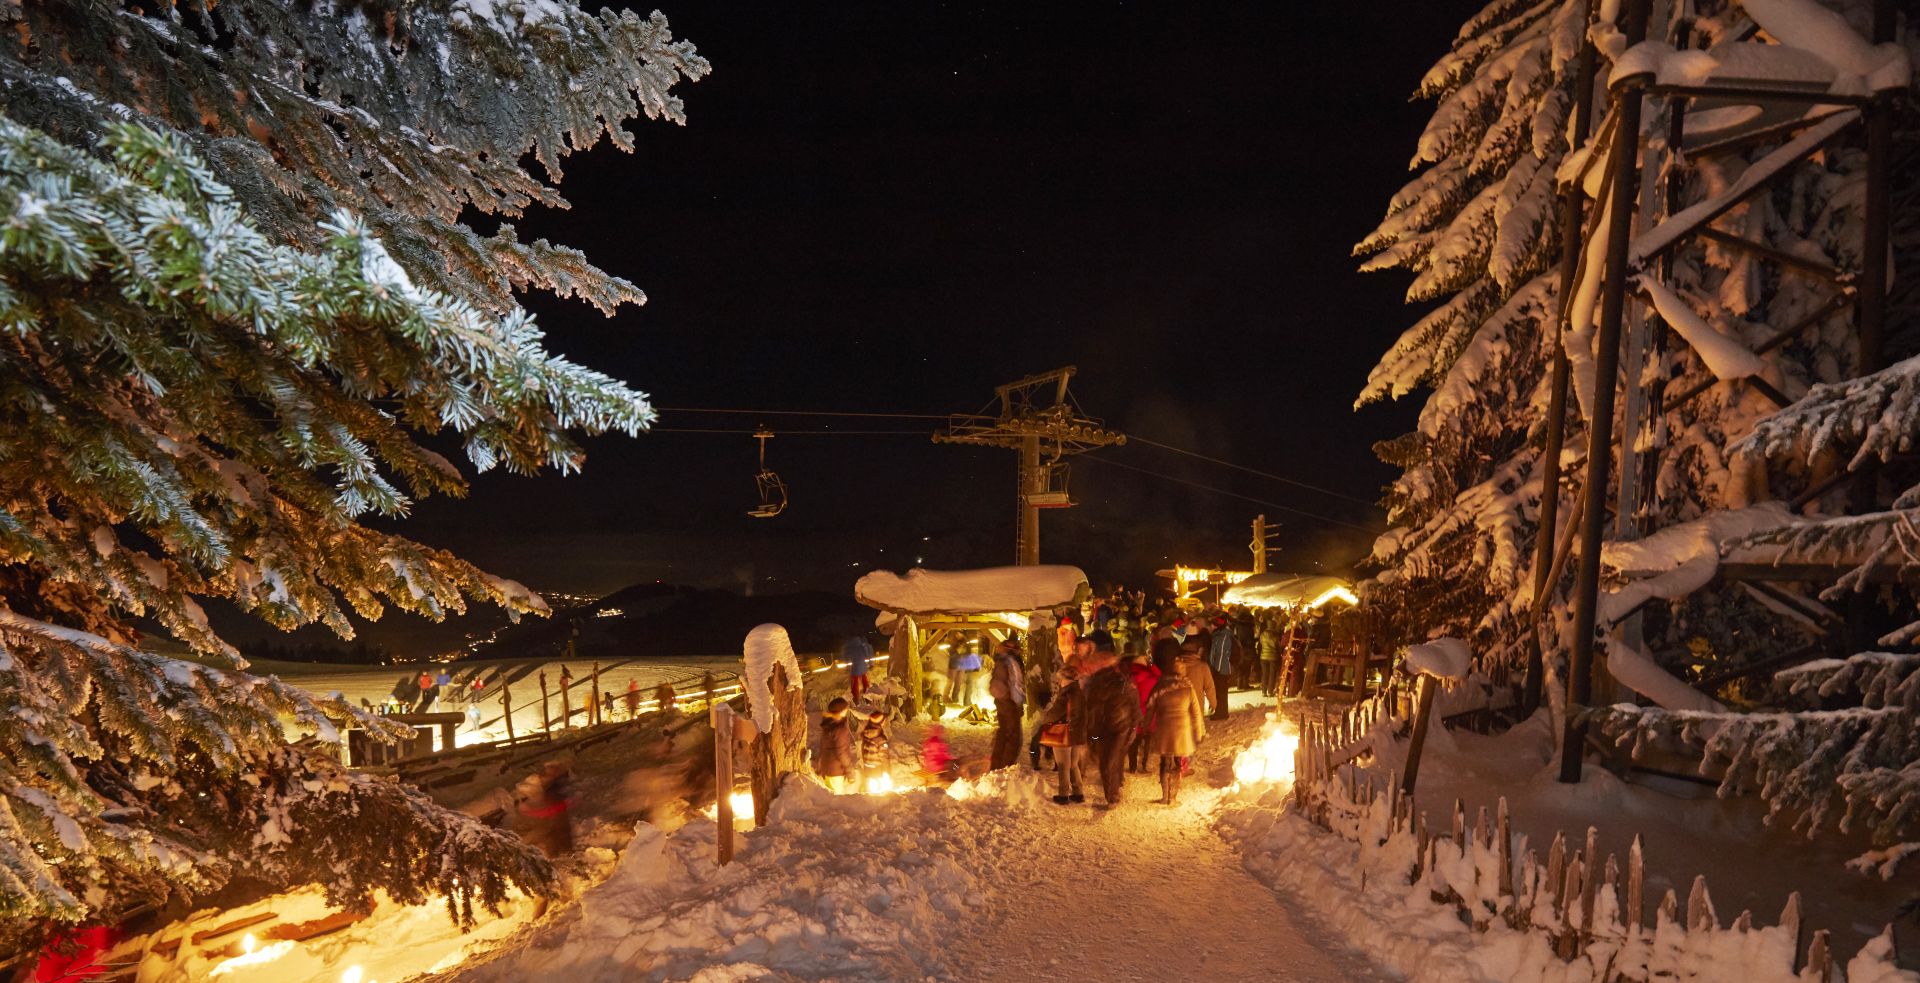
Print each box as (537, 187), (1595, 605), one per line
(0, 0), (707, 956)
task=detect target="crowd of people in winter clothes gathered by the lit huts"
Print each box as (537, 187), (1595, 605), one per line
(814, 587), (1325, 806)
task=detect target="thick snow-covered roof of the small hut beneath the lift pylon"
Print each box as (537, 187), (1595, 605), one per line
(852, 566), (1087, 616)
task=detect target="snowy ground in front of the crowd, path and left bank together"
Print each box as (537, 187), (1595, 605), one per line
(436, 687), (1371, 983)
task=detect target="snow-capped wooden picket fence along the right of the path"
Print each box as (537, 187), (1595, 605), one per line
(1292, 721), (1901, 983)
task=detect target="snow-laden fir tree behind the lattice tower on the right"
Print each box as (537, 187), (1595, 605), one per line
(1357, 0), (1920, 862)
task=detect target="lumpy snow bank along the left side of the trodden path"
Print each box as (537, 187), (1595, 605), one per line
(455, 770), (1062, 983)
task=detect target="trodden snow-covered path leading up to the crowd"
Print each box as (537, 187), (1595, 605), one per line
(943, 778), (1375, 981)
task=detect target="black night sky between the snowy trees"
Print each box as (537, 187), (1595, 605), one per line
(382, 0), (1478, 614)
